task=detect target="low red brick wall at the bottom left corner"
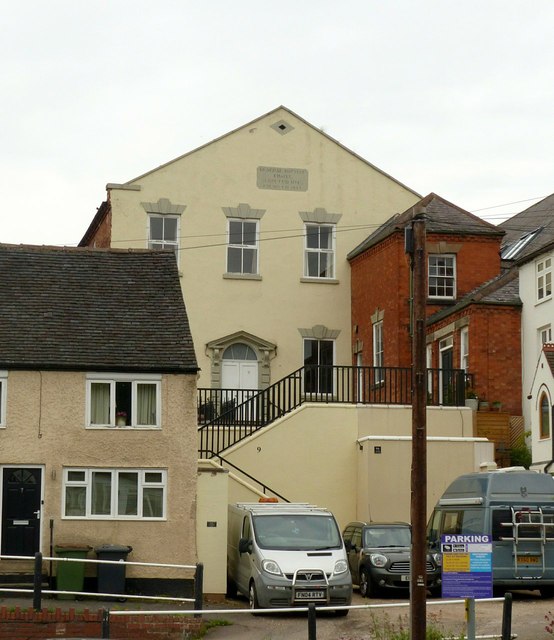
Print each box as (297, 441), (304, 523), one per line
(0, 607), (202, 640)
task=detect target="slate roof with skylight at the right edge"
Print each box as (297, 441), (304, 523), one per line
(500, 194), (554, 264)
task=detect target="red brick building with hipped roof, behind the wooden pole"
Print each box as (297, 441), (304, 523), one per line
(348, 193), (521, 415)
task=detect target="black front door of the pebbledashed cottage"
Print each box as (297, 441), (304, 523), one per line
(2, 467), (42, 556)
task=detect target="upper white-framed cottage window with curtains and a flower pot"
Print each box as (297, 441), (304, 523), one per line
(87, 375), (161, 428)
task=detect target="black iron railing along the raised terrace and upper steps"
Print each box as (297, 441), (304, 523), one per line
(198, 365), (466, 457)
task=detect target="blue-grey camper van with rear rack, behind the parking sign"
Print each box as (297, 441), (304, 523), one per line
(427, 467), (554, 598)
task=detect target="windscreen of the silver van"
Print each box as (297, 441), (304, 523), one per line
(252, 513), (342, 551)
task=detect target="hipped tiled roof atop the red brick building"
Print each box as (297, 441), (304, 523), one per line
(348, 193), (504, 260)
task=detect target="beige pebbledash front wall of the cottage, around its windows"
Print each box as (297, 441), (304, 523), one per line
(0, 371), (197, 584)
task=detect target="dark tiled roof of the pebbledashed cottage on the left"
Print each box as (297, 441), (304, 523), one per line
(0, 244), (198, 373)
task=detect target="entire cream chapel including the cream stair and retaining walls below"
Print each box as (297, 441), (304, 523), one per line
(80, 107), (492, 594)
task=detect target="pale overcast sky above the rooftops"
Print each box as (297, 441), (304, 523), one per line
(0, 0), (554, 245)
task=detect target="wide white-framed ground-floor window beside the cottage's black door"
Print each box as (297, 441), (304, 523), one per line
(62, 468), (167, 520)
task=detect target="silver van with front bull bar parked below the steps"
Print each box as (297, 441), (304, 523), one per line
(227, 502), (352, 615)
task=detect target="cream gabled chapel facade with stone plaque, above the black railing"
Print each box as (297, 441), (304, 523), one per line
(81, 107), (419, 389)
